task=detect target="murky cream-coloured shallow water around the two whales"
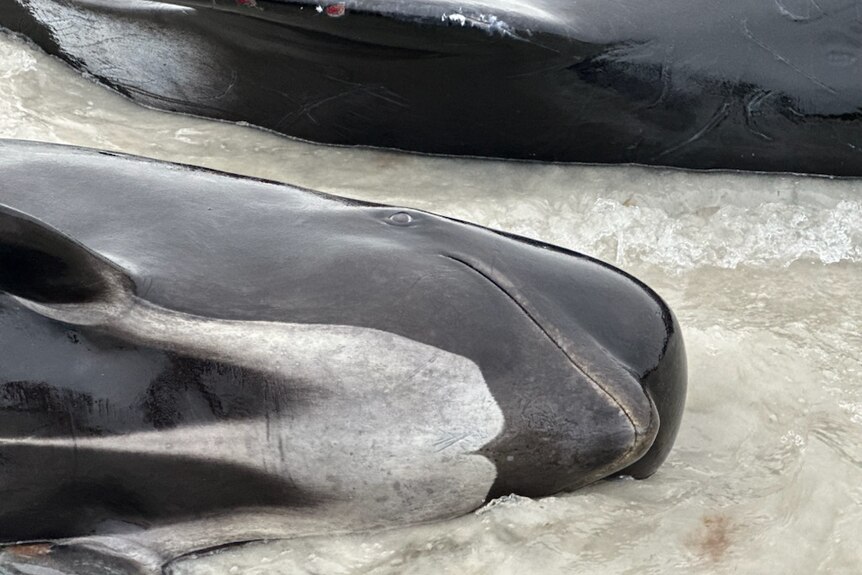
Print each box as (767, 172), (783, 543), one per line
(0, 30), (862, 575)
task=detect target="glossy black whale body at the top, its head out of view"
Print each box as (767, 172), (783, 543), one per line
(0, 0), (862, 176)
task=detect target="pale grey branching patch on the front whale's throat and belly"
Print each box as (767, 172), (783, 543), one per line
(0, 296), (503, 557)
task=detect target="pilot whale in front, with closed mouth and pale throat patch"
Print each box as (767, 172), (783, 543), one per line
(0, 140), (686, 574)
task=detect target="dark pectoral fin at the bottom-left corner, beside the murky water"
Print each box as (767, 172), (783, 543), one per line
(0, 541), (162, 575)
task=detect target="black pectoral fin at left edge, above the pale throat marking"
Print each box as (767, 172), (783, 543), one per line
(0, 204), (134, 316)
